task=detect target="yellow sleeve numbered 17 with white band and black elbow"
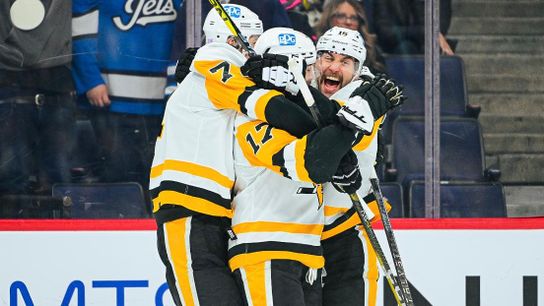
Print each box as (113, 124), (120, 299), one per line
(236, 119), (355, 184)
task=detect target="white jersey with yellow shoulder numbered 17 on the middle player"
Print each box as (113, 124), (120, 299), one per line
(229, 116), (324, 270)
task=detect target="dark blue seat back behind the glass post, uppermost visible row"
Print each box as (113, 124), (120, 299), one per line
(386, 55), (480, 118)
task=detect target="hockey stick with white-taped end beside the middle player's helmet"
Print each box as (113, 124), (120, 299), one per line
(289, 59), (413, 306)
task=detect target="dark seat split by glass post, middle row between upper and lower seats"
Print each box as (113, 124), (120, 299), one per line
(387, 117), (498, 186)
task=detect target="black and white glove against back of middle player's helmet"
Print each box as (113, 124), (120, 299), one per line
(240, 53), (299, 95)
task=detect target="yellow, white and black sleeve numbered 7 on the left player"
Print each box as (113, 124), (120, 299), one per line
(193, 60), (316, 137)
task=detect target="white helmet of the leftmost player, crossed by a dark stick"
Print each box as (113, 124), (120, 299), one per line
(202, 4), (263, 43)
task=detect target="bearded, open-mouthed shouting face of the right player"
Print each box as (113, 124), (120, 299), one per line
(317, 52), (356, 97)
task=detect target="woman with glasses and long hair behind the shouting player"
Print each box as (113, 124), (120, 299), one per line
(317, 0), (385, 73)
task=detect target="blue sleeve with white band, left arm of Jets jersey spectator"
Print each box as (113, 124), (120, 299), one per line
(72, 0), (104, 94)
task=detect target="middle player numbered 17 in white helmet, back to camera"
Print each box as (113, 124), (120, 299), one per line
(229, 28), (404, 305)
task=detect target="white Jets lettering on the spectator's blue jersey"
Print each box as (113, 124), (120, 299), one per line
(113, 0), (177, 31)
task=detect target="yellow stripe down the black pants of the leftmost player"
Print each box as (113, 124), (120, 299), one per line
(165, 218), (197, 306)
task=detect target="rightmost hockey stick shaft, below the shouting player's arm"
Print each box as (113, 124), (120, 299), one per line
(370, 172), (414, 306)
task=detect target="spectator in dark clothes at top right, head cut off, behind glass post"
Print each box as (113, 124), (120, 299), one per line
(374, 0), (455, 55)
